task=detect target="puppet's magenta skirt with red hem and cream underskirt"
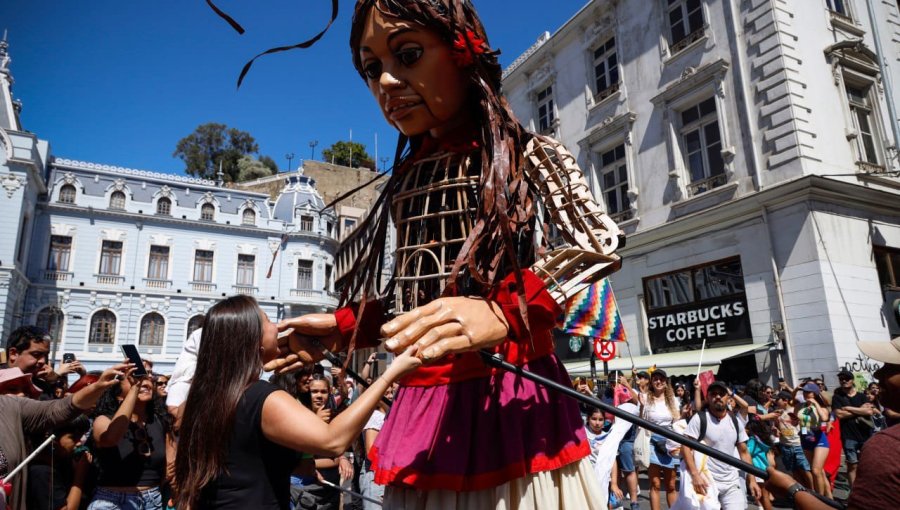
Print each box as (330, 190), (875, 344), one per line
(369, 354), (597, 508)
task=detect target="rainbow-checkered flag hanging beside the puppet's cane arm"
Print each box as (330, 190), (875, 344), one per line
(562, 278), (625, 342)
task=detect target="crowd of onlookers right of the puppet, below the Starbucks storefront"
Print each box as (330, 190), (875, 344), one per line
(574, 356), (900, 510)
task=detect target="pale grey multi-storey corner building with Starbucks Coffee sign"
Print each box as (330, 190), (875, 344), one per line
(504, 0), (900, 382)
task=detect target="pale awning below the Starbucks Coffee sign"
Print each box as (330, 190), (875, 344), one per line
(565, 344), (772, 377)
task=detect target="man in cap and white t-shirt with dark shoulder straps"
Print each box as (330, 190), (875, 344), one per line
(682, 381), (760, 510)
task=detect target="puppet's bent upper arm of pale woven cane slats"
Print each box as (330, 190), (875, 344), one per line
(525, 137), (621, 305)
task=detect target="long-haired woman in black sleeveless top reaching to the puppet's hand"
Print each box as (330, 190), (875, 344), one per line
(175, 296), (421, 510)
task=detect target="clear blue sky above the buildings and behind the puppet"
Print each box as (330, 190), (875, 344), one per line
(0, 0), (587, 173)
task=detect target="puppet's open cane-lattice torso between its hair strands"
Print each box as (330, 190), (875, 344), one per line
(392, 153), (478, 313)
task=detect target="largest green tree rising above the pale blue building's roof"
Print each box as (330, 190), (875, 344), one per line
(172, 122), (262, 182)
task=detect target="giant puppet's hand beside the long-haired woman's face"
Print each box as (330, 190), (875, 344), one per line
(263, 313), (341, 374)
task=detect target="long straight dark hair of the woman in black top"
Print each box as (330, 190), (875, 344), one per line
(175, 296), (262, 508)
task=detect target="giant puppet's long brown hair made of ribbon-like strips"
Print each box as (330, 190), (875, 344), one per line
(341, 0), (534, 342)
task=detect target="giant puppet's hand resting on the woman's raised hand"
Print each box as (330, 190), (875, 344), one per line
(381, 297), (509, 361)
